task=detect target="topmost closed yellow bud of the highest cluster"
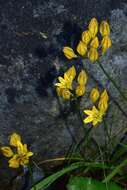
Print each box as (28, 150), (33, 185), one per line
(88, 18), (98, 38)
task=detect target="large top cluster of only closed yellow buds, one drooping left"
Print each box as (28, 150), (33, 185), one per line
(63, 18), (111, 62)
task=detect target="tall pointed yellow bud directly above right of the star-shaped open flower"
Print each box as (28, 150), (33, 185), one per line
(98, 90), (109, 114)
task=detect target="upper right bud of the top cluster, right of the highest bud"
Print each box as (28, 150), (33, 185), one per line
(100, 21), (110, 36)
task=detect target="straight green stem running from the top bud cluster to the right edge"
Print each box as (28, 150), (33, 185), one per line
(97, 61), (127, 101)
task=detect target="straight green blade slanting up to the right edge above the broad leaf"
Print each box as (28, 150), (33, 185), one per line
(103, 159), (127, 183)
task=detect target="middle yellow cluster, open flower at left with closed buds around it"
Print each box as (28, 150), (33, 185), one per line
(55, 66), (87, 100)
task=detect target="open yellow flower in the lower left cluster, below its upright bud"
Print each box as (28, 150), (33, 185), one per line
(8, 141), (33, 168)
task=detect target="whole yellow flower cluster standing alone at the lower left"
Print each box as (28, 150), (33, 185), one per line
(1, 133), (33, 168)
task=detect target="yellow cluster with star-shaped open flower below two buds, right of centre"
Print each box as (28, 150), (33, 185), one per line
(84, 88), (109, 126)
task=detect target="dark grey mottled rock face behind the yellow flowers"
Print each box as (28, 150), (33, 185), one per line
(0, 0), (127, 189)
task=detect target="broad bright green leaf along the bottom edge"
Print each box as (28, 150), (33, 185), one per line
(67, 177), (123, 190)
